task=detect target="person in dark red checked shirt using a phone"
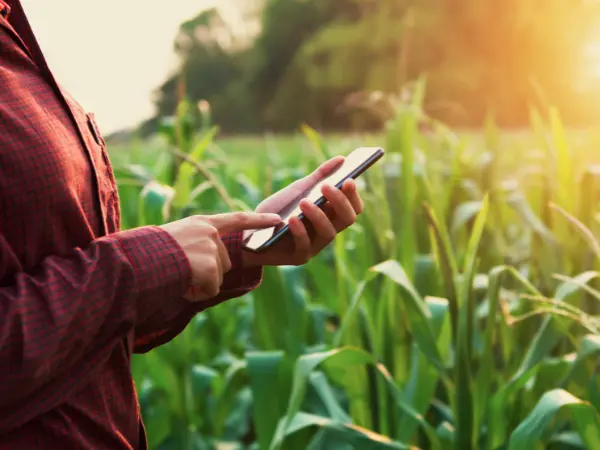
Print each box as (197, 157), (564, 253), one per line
(0, 0), (363, 450)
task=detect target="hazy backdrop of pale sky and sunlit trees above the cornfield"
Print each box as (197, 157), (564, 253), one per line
(24, 0), (600, 134)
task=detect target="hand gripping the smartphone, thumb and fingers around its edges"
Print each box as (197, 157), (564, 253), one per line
(243, 156), (363, 267)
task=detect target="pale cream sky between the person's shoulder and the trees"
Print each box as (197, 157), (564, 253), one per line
(21, 0), (235, 134)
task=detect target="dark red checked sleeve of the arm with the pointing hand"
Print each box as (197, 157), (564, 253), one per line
(0, 227), (191, 408)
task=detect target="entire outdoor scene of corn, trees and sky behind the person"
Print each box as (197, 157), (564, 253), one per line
(22, 0), (600, 450)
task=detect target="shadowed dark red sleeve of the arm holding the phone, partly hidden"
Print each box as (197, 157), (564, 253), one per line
(134, 233), (263, 353)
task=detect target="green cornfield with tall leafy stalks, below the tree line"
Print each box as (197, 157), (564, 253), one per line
(111, 84), (600, 450)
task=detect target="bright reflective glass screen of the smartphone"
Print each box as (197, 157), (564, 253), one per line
(244, 147), (383, 250)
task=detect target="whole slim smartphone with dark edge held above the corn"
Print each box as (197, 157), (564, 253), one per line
(243, 147), (384, 253)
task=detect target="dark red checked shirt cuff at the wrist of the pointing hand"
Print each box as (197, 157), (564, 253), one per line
(108, 226), (192, 322)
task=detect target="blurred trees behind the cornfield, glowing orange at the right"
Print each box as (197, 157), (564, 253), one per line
(141, 0), (600, 133)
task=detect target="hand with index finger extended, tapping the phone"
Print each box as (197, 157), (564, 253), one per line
(161, 212), (281, 302)
